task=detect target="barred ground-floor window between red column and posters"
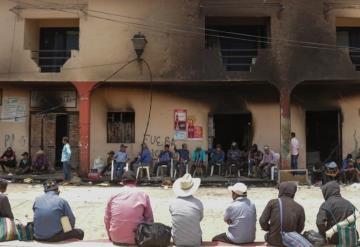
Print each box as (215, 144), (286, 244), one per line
(107, 112), (135, 143)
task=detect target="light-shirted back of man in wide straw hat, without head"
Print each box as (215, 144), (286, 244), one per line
(170, 196), (204, 246)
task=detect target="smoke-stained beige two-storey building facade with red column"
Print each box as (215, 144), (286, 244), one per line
(0, 0), (360, 175)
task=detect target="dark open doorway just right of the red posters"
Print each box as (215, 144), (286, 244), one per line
(209, 113), (252, 152)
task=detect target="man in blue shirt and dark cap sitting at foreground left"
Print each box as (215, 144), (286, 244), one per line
(33, 180), (84, 242)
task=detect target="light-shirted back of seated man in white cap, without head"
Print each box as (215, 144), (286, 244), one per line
(224, 197), (256, 244)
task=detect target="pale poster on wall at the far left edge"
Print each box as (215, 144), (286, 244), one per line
(1, 97), (27, 123)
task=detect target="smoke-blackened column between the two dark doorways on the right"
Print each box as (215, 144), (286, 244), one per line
(280, 86), (291, 170)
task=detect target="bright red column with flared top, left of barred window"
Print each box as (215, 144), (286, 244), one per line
(72, 81), (97, 177)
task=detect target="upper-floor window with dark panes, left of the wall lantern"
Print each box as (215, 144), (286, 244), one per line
(38, 27), (79, 72)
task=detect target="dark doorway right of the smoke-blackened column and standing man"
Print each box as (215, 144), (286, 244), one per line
(306, 110), (342, 164)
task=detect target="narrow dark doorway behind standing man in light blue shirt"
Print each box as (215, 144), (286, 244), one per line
(55, 114), (69, 167)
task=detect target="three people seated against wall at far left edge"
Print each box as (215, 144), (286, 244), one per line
(0, 147), (50, 175)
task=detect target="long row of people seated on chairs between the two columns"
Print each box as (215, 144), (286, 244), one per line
(101, 142), (280, 178)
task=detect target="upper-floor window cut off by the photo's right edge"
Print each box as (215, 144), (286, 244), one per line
(336, 27), (360, 70)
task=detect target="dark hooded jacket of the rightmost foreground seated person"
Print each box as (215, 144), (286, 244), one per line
(316, 181), (354, 244)
